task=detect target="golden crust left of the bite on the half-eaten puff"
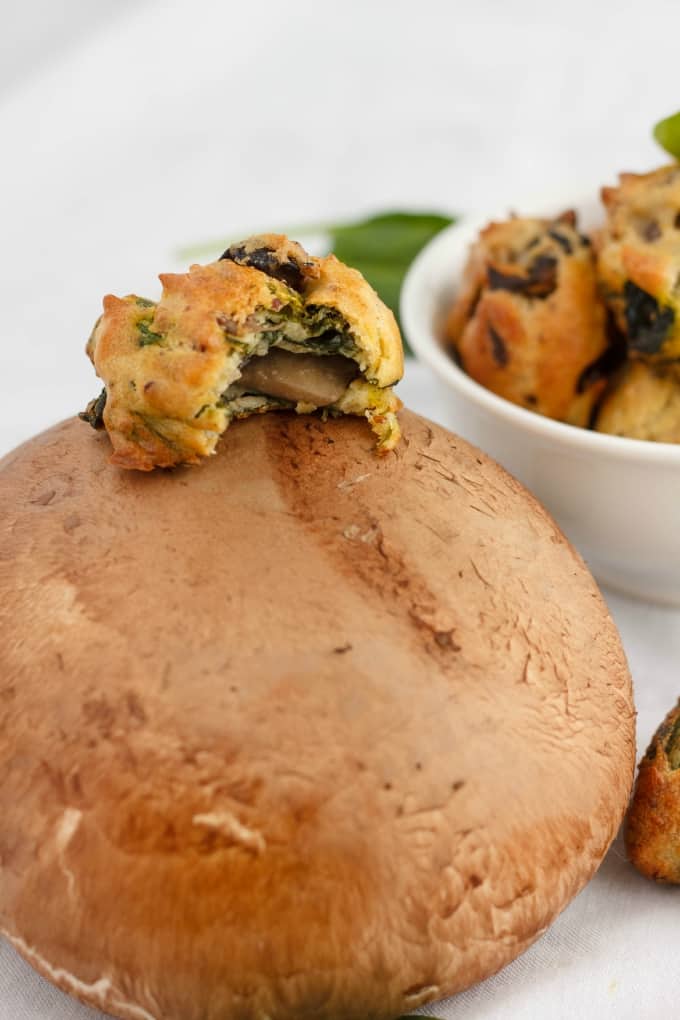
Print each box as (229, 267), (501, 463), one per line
(90, 261), (294, 470)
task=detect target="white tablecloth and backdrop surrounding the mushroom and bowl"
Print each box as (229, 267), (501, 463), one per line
(0, 0), (680, 1020)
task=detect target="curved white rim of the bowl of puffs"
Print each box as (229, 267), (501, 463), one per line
(400, 216), (680, 467)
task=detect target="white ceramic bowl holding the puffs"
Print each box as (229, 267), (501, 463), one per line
(401, 201), (680, 606)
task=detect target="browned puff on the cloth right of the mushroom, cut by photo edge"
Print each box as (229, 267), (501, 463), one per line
(625, 702), (680, 883)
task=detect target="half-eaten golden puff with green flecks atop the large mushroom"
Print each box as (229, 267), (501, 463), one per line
(81, 234), (404, 471)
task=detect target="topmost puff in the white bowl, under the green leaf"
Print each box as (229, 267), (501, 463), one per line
(594, 163), (680, 360)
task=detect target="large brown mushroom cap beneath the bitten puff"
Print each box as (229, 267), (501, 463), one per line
(0, 413), (634, 1020)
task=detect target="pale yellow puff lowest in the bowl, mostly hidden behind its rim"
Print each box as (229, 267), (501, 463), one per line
(594, 360), (680, 443)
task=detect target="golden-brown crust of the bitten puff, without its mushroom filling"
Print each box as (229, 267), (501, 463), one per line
(88, 235), (403, 470)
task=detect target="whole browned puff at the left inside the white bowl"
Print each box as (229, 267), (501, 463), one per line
(446, 212), (608, 425)
